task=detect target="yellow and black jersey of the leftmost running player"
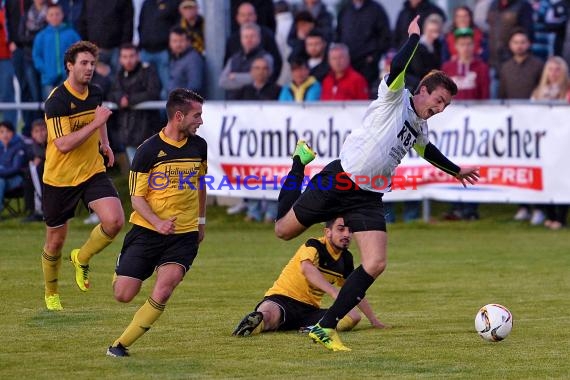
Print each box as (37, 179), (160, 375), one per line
(44, 81), (105, 187)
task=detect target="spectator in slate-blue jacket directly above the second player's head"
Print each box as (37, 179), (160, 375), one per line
(166, 27), (205, 93)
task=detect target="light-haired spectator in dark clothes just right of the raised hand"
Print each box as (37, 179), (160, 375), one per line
(406, 13), (444, 93)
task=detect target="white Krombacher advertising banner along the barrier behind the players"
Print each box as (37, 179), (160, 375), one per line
(0, 101), (570, 212)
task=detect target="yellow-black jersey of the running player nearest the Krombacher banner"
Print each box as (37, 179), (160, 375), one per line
(129, 131), (208, 233)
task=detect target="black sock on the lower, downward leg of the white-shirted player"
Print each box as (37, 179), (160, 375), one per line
(319, 265), (374, 328)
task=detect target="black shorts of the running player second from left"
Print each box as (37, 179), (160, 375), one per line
(115, 225), (198, 281)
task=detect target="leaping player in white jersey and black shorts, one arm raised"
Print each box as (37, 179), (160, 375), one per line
(275, 17), (479, 351)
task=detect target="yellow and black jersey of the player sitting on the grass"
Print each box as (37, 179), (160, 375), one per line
(265, 236), (354, 307)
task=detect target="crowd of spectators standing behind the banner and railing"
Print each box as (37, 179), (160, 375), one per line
(0, 0), (570, 229)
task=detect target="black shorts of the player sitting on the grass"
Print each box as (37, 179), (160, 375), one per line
(255, 294), (327, 330)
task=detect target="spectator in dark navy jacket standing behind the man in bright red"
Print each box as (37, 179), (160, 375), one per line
(337, 0), (390, 92)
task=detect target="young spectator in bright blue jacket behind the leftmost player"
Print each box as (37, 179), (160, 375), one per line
(32, 4), (81, 99)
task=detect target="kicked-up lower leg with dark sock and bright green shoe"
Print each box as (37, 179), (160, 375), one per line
(277, 140), (316, 220)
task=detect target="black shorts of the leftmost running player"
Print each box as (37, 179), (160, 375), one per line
(42, 173), (119, 227)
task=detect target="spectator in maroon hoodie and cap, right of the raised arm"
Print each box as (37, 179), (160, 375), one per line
(441, 28), (490, 100)
